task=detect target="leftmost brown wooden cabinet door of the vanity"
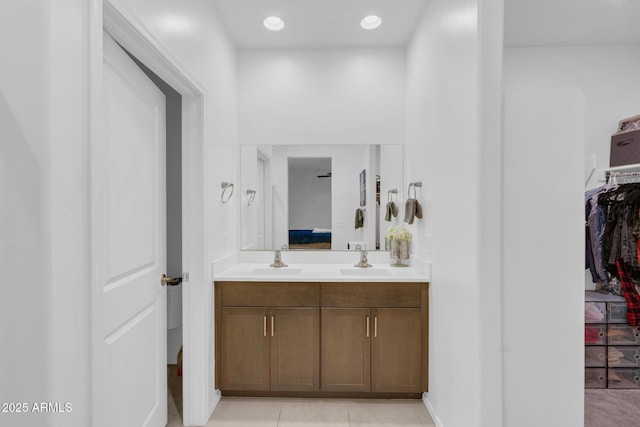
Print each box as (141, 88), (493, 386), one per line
(216, 307), (269, 390)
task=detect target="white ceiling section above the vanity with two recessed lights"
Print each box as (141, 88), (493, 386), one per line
(213, 0), (427, 48)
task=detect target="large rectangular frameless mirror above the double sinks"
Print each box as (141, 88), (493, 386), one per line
(240, 144), (404, 250)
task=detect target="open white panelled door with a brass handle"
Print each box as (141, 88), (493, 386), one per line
(97, 33), (167, 427)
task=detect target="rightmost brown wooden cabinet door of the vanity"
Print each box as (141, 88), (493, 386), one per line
(371, 308), (426, 393)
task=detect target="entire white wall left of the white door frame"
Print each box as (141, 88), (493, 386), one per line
(0, 0), (96, 426)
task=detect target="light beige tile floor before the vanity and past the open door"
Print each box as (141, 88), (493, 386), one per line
(167, 366), (435, 427)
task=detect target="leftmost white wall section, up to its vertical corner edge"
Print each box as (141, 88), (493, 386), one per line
(0, 0), (55, 426)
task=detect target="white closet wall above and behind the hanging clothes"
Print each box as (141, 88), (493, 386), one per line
(504, 45), (640, 289)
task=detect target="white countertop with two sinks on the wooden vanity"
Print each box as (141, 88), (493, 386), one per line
(214, 263), (429, 282)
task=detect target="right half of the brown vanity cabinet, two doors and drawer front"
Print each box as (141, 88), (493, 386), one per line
(320, 283), (427, 393)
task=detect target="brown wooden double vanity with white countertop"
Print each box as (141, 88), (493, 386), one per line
(215, 266), (429, 397)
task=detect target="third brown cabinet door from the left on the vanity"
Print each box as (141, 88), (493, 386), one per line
(320, 308), (371, 391)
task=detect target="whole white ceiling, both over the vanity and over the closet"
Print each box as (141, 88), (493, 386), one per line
(212, 0), (640, 48)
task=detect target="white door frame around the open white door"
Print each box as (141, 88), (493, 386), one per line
(87, 0), (212, 426)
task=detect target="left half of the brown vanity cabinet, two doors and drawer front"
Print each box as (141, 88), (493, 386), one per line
(216, 282), (320, 391)
